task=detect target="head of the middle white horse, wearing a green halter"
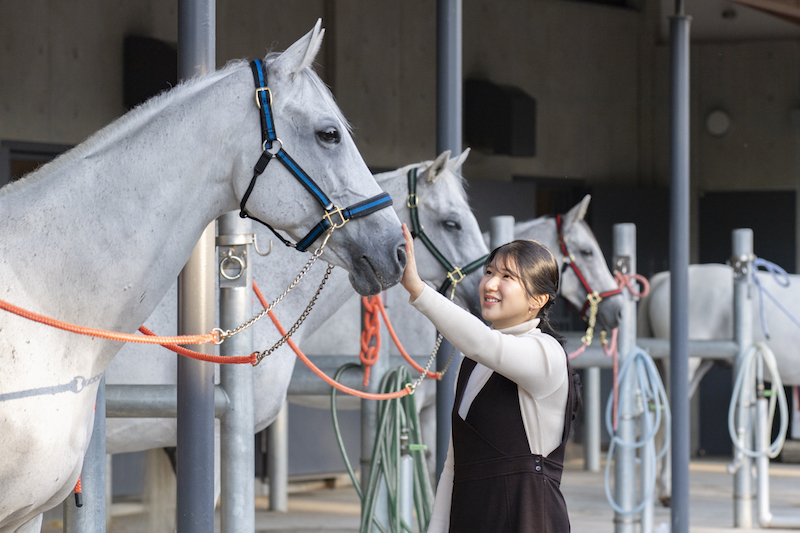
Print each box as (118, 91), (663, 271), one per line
(378, 148), (489, 314)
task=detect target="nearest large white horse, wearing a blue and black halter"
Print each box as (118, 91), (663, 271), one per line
(0, 22), (405, 533)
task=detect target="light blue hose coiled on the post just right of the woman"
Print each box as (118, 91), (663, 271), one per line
(605, 346), (672, 515)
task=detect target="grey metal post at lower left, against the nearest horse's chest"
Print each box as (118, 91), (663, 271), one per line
(63, 377), (111, 533)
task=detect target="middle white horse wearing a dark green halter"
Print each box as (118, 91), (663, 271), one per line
(106, 150), (488, 516)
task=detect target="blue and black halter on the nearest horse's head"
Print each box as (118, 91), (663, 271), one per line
(239, 59), (392, 252)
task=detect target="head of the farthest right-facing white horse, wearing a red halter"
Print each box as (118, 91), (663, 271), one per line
(550, 194), (623, 331)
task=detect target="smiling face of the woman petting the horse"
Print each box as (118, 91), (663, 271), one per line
(478, 260), (535, 329)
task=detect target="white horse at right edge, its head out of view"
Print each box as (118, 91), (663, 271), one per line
(637, 264), (800, 504)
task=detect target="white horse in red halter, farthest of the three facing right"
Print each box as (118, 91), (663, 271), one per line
(300, 195), (623, 472)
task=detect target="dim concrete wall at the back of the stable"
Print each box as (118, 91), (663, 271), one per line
(0, 0), (800, 257)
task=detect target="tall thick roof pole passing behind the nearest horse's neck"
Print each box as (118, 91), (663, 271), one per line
(177, 0), (216, 533)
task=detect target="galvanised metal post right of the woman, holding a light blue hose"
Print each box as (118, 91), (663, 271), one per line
(609, 224), (639, 533)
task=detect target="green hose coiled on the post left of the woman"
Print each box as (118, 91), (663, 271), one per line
(331, 363), (434, 533)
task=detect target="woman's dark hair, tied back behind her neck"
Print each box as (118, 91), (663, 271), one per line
(485, 239), (583, 418)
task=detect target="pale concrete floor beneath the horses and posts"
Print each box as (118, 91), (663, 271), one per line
(42, 459), (800, 533)
